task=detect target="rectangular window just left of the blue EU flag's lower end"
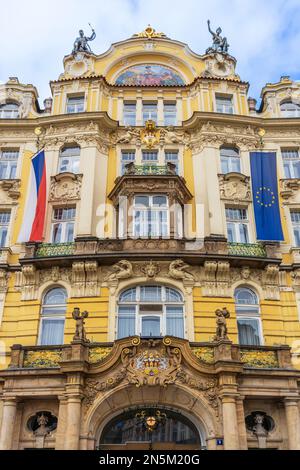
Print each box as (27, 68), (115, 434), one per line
(226, 208), (249, 243)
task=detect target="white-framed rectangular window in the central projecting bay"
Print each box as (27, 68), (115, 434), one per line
(133, 196), (169, 238)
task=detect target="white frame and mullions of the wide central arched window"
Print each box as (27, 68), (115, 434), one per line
(116, 284), (186, 339)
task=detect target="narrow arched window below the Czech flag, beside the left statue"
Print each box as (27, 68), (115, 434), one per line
(39, 287), (67, 345)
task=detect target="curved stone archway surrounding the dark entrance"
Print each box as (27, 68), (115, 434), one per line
(80, 384), (222, 450)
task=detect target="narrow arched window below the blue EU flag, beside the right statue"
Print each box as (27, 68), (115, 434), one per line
(234, 287), (262, 346)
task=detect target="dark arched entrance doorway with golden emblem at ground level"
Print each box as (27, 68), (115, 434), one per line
(98, 406), (204, 450)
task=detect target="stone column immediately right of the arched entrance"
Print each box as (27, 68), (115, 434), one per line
(222, 396), (240, 450)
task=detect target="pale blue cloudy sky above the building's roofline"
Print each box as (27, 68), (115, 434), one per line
(0, 0), (300, 105)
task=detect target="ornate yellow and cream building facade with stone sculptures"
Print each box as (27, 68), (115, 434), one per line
(0, 27), (300, 450)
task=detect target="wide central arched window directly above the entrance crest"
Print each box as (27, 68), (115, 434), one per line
(117, 286), (184, 338)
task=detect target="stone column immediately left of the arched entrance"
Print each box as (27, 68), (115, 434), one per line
(65, 395), (81, 450)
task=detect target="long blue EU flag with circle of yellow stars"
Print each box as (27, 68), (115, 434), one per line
(250, 152), (283, 241)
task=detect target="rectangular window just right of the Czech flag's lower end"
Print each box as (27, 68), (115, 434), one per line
(51, 207), (76, 243)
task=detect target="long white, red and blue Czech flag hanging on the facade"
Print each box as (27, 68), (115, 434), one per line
(18, 150), (47, 243)
